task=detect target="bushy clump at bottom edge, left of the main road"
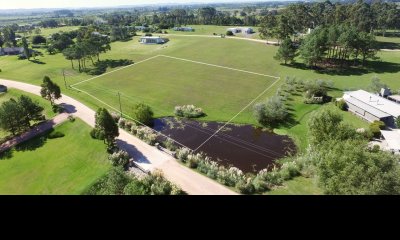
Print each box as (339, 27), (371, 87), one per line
(84, 167), (185, 195)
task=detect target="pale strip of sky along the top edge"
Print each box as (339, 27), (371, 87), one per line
(0, 0), (268, 9)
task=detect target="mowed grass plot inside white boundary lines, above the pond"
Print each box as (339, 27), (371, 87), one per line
(75, 56), (277, 123)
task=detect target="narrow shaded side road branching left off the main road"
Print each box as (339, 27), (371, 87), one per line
(0, 113), (69, 152)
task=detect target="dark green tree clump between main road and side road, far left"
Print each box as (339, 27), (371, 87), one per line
(0, 95), (45, 135)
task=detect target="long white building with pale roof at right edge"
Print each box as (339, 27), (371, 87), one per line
(343, 90), (400, 127)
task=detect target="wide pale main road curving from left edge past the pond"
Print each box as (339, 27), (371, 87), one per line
(0, 79), (237, 195)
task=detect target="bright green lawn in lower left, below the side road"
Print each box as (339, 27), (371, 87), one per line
(0, 119), (110, 194)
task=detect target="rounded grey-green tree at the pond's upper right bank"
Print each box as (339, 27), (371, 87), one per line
(254, 96), (289, 127)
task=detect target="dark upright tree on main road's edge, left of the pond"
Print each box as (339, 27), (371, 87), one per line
(95, 108), (119, 148)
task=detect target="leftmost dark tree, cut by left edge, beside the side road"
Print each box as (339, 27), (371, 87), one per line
(0, 98), (28, 135)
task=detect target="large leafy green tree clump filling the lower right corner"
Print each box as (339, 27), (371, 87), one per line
(304, 108), (400, 194)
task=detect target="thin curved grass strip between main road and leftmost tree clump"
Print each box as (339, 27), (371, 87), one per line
(0, 89), (56, 138)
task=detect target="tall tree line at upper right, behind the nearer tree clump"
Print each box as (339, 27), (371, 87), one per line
(260, 0), (400, 40)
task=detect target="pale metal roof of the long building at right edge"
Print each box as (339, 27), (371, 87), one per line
(343, 90), (400, 118)
